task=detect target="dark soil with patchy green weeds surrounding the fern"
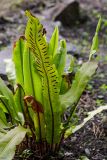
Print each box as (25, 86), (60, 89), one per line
(0, 0), (107, 160)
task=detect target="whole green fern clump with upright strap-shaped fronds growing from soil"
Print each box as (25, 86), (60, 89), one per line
(0, 11), (104, 160)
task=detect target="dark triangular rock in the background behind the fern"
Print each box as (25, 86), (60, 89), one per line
(54, 0), (87, 27)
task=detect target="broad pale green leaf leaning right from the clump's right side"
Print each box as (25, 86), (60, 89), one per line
(60, 62), (98, 108)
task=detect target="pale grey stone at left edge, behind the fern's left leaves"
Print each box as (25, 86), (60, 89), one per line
(0, 46), (12, 75)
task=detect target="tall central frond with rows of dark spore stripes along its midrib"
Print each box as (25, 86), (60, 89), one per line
(25, 11), (61, 143)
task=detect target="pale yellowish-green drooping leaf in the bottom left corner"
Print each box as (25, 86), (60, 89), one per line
(0, 126), (27, 160)
